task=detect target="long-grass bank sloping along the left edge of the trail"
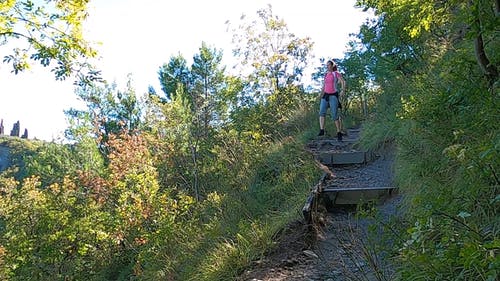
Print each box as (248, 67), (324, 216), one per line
(179, 130), (318, 280)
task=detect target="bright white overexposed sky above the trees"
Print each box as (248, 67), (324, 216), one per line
(0, 0), (370, 141)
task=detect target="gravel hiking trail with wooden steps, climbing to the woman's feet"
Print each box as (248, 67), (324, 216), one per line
(237, 129), (401, 281)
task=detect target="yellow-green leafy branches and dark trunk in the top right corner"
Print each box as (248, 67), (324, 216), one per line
(358, 0), (500, 87)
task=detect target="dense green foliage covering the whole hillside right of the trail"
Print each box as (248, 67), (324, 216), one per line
(347, 0), (500, 280)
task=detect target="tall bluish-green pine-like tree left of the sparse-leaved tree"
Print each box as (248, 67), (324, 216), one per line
(150, 42), (242, 200)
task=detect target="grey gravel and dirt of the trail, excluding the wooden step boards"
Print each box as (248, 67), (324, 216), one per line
(237, 134), (402, 281)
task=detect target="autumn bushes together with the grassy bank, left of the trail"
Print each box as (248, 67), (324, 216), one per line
(0, 103), (317, 280)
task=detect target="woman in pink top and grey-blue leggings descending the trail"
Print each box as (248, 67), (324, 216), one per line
(318, 60), (345, 141)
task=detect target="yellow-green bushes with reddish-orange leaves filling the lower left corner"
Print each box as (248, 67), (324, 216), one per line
(0, 130), (196, 280)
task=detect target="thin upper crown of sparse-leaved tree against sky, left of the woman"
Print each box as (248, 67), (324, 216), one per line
(229, 5), (313, 100)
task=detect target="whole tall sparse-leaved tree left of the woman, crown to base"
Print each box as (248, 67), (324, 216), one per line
(228, 5), (313, 141)
